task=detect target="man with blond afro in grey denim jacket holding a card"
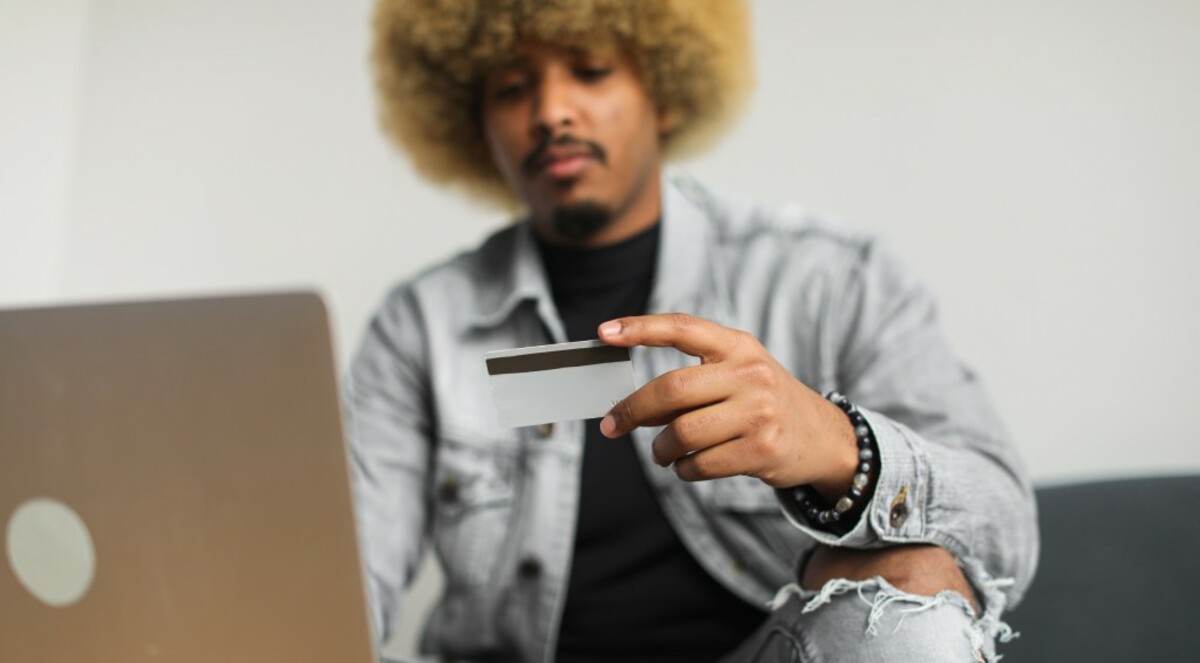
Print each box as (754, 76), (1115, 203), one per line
(348, 0), (1036, 661)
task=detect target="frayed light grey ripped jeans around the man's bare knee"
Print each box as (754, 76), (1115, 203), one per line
(721, 565), (1015, 663)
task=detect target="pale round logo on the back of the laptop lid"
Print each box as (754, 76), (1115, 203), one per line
(5, 497), (96, 608)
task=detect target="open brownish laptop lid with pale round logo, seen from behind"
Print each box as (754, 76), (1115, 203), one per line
(0, 293), (378, 663)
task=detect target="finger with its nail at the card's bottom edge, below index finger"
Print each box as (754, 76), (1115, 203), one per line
(600, 365), (734, 437)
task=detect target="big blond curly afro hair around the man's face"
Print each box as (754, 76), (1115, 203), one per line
(372, 0), (752, 207)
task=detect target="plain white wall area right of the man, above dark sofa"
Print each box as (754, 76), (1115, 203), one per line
(695, 0), (1200, 487)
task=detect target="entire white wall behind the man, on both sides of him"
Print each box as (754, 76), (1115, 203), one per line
(0, 0), (1200, 641)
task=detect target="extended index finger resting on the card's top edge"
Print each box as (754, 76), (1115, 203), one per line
(599, 313), (752, 363)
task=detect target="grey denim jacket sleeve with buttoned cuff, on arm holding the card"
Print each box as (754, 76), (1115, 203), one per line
(779, 237), (1038, 605)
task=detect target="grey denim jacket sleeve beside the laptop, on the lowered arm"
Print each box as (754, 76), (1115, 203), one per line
(344, 288), (433, 643)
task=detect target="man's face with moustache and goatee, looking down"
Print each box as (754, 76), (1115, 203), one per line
(482, 43), (662, 243)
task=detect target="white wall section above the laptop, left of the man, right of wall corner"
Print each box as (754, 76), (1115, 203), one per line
(60, 0), (486, 359)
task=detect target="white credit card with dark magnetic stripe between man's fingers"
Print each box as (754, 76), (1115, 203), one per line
(486, 340), (634, 428)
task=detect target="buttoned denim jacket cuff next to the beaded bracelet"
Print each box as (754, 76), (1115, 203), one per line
(775, 407), (929, 548)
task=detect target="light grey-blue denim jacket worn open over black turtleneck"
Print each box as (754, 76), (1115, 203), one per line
(347, 175), (1037, 662)
